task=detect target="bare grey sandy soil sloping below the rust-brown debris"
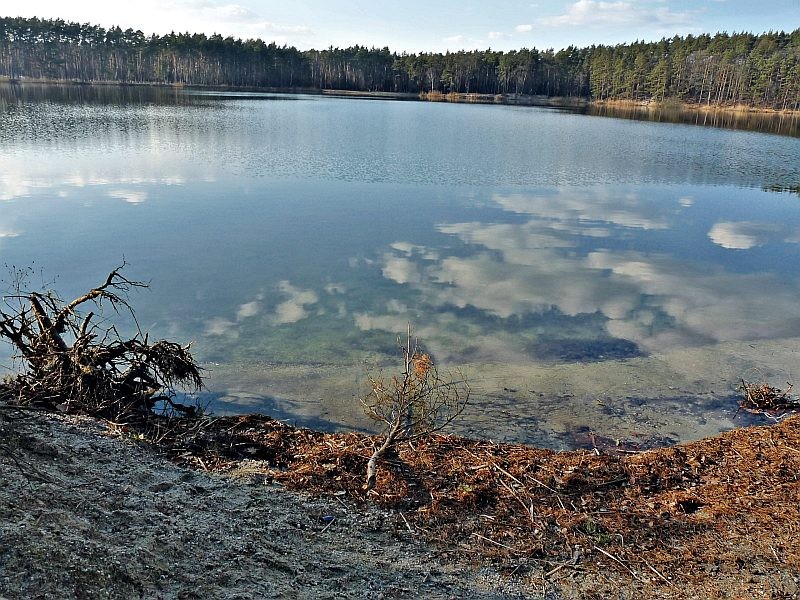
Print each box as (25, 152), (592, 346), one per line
(0, 405), (800, 599)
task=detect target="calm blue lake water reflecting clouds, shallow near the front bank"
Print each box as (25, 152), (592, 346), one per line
(0, 86), (800, 448)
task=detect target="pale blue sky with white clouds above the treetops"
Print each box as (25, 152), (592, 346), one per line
(0, 0), (800, 52)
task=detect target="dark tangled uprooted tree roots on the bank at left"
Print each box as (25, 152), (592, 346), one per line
(0, 265), (202, 420)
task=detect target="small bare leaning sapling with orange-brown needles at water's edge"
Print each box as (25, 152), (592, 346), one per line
(361, 325), (470, 491)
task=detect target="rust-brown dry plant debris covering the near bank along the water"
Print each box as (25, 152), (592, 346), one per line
(148, 416), (800, 587)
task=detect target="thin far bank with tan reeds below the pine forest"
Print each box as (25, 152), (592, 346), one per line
(0, 76), (800, 118)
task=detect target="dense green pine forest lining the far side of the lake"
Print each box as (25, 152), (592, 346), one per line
(0, 18), (800, 110)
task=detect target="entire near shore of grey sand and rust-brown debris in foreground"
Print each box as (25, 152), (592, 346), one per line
(0, 404), (800, 599)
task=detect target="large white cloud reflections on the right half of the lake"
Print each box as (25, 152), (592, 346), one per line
(366, 188), (800, 351)
